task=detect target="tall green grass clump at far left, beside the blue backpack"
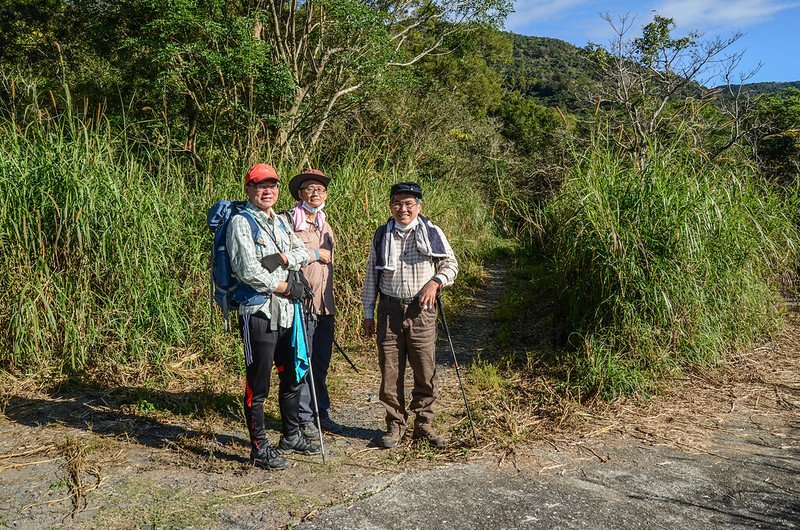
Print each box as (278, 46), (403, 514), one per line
(0, 87), (212, 370)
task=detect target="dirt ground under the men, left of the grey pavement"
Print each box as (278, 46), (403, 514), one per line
(0, 262), (502, 529)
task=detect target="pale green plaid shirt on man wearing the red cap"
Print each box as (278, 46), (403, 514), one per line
(225, 202), (309, 329)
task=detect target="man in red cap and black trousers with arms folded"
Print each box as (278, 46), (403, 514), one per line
(226, 164), (321, 469)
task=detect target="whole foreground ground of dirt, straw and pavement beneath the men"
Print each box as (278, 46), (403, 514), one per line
(0, 267), (800, 529)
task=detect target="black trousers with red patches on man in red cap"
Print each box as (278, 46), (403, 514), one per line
(239, 315), (300, 449)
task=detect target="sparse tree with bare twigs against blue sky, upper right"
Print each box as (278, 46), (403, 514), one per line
(587, 15), (742, 167)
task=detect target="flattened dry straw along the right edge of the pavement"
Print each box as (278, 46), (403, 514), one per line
(524, 313), (800, 453)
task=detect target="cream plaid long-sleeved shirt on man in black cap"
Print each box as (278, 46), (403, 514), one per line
(361, 224), (458, 319)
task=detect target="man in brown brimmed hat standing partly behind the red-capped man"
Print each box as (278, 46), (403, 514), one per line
(286, 169), (343, 439)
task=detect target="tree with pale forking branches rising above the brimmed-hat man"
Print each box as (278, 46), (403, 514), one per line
(258, 0), (511, 161)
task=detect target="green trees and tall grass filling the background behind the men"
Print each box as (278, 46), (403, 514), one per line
(0, 4), (800, 397)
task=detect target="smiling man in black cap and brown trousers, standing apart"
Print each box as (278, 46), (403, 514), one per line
(362, 182), (458, 448)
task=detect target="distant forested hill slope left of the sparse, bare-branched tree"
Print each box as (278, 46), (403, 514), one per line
(505, 33), (600, 111)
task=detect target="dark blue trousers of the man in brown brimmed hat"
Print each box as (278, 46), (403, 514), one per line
(300, 315), (334, 422)
